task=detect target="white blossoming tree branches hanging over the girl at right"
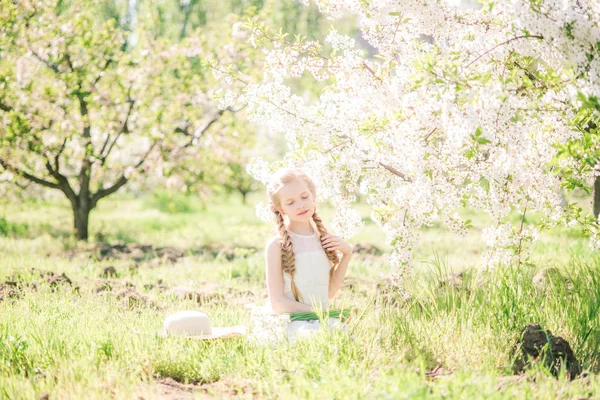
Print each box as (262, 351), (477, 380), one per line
(240, 0), (600, 271)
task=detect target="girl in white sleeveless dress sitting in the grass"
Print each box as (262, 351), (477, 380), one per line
(265, 169), (352, 340)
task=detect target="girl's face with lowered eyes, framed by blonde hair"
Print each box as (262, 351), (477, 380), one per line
(279, 179), (315, 222)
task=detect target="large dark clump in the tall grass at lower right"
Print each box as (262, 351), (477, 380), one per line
(513, 324), (581, 379)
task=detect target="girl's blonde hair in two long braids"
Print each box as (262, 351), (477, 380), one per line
(267, 168), (340, 301)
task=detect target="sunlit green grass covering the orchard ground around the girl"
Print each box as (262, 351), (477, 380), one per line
(0, 195), (600, 399)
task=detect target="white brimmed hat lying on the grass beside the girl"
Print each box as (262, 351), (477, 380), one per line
(163, 311), (246, 339)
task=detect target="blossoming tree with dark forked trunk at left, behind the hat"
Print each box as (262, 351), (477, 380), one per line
(0, 0), (256, 239)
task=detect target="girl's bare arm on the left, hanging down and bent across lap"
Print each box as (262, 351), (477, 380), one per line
(265, 238), (312, 312)
